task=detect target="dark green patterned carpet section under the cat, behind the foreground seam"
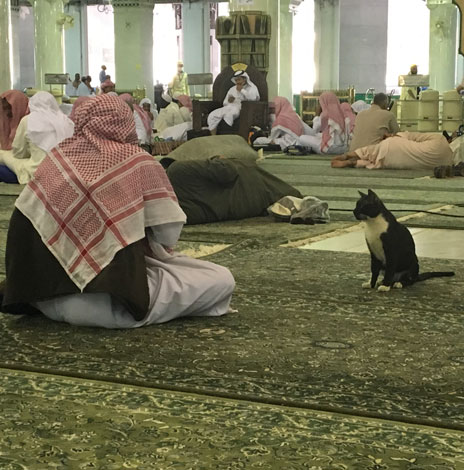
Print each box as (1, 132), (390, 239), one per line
(0, 248), (464, 430)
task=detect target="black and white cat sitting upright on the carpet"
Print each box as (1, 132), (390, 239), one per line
(353, 189), (454, 292)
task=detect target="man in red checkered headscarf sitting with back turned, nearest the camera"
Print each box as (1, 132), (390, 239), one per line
(3, 95), (234, 328)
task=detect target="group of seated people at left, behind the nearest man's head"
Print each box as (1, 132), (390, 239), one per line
(0, 84), (187, 179)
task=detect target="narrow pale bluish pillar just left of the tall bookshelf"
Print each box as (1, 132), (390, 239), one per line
(182, 2), (210, 73)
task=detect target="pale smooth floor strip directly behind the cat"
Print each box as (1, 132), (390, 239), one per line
(300, 225), (464, 259)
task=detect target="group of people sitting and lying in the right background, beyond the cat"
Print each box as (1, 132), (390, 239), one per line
(250, 88), (461, 173)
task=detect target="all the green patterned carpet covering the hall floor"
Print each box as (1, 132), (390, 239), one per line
(0, 157), (464, 470)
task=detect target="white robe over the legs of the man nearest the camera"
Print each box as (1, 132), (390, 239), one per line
(35, 222), (235, 328)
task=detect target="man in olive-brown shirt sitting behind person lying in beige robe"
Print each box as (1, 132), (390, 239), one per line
(350, 93), (400, 152)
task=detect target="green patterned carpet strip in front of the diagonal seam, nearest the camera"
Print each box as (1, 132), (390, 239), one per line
(0, 370), (464, 470)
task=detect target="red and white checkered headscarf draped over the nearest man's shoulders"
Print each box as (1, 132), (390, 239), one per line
(16, 95), (186, 290)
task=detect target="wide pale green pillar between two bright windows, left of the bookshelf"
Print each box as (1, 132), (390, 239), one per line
(112, 0), (155, 101)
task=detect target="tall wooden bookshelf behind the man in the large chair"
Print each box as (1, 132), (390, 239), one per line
(216, 11), (271, 74)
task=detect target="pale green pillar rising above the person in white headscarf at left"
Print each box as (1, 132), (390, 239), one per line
(33, 0), (64, 91)
